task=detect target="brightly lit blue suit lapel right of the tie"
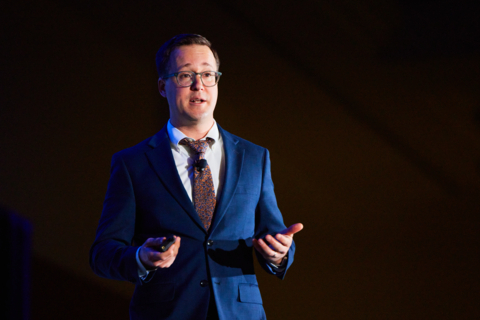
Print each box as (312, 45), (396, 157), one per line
(209, 126), (245, 233)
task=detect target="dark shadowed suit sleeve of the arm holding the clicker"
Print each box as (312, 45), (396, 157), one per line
(90, 154), (140, 283)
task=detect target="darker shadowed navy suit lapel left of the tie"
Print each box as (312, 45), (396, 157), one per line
(146, 126), (205, 232)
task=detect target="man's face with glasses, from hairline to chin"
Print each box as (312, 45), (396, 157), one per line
(158, 45), (218, 127)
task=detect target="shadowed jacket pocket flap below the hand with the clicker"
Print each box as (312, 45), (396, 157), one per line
(132, 283), (175, 306)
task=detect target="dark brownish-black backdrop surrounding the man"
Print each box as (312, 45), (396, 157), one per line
(0, 0), (480, 320)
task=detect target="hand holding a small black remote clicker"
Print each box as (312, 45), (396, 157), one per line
(142, 236), (181, 270)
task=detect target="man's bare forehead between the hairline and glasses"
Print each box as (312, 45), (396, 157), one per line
(170, 44), (216, 71)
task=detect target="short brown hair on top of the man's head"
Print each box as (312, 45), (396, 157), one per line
(155, 33), (220, 78)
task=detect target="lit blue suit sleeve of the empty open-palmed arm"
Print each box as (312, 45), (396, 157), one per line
(255, 149), (295, 279)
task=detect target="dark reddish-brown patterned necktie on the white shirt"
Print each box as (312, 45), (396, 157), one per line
(179, 138), (216, 231)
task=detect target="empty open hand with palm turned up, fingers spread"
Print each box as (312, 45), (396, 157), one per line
(253, 223), (303, 265)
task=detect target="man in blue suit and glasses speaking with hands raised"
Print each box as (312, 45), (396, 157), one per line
(90, 34), (303, 320)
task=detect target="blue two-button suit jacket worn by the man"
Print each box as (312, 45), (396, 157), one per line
(90, 126), (295, 320)
